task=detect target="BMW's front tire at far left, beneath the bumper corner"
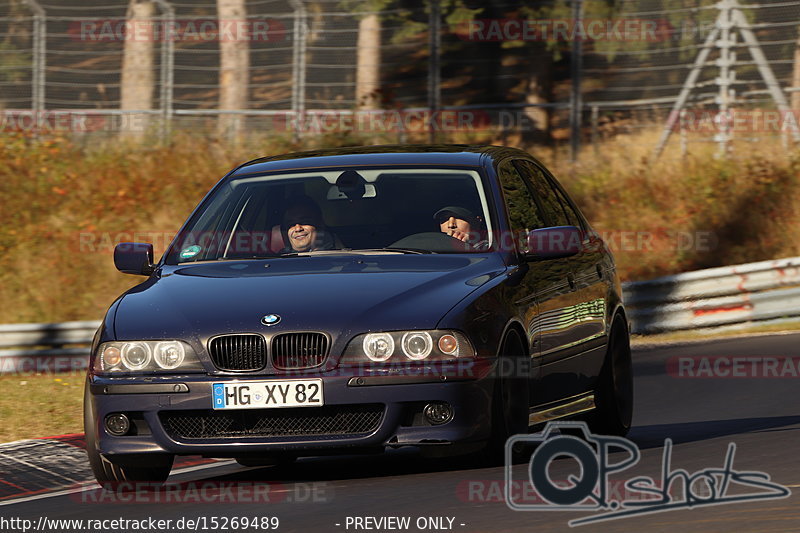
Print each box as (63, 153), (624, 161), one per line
(83, 380), (175, 490)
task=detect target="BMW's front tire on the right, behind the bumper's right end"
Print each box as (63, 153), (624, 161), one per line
(483, 330), (530, 465)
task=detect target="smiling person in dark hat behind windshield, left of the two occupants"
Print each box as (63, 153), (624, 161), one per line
(280, 196), (335, 253)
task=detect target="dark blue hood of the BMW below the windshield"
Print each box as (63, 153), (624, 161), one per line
(114, 254), (505, 350)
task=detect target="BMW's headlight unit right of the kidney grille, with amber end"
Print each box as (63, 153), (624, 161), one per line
(341, 330), (475, 364)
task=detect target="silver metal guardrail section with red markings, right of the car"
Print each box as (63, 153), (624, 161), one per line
(623, 257), (800, 334)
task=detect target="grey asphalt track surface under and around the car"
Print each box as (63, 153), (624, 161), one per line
(0, 334), (800, 533)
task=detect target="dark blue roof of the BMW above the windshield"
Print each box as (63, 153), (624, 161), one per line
(230, 144), (530, 177)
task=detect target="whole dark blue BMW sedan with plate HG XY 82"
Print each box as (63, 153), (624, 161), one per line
(84, 145), (633, 484)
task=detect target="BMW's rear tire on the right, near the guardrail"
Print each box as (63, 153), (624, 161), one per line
(587, 315), (633, 437)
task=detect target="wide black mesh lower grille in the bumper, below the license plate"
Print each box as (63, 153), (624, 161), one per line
(158, 404), (384, 440)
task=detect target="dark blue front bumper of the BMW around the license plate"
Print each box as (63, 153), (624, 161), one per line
(86, 360), (495, 457)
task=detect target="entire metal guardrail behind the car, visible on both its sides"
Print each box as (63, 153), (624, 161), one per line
(0, 257), (800, 374)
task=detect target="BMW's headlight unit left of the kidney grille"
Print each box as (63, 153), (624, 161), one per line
(93, 340), (204, 375)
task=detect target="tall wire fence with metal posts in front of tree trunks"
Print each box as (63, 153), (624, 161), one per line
(0, 0), (800, 158)
